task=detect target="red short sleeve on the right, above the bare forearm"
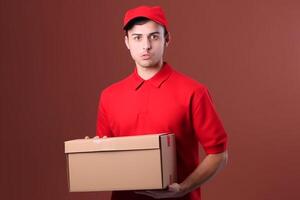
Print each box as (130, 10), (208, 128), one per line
(192, 87), (227, 154)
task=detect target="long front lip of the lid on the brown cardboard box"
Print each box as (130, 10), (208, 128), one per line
(65, 133), (168, 153)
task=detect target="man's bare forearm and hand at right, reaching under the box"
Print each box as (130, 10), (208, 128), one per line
(136, 151), (228, 199)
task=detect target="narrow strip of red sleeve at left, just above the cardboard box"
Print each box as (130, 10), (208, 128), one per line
(96, 93), (112, 137)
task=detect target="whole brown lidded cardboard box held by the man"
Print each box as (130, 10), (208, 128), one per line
(65, 134), (176, 192)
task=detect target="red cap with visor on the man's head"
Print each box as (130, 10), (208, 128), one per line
(123, 6), (168, 30)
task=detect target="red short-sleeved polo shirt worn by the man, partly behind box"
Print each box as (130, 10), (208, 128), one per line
(97, 63), (227, 200)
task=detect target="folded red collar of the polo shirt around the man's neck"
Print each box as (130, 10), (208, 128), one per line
(131, 62), (173, 90)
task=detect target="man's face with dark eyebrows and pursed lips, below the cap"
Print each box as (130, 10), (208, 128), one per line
(125, 21), (167, 68)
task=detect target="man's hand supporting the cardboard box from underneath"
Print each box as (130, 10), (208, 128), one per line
(135, 183), (186, 199)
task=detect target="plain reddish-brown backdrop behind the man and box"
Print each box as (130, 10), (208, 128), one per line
(0, 0), (300, 200)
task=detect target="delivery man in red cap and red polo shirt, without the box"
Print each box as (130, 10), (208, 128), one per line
(97, 6), (227, 200)
